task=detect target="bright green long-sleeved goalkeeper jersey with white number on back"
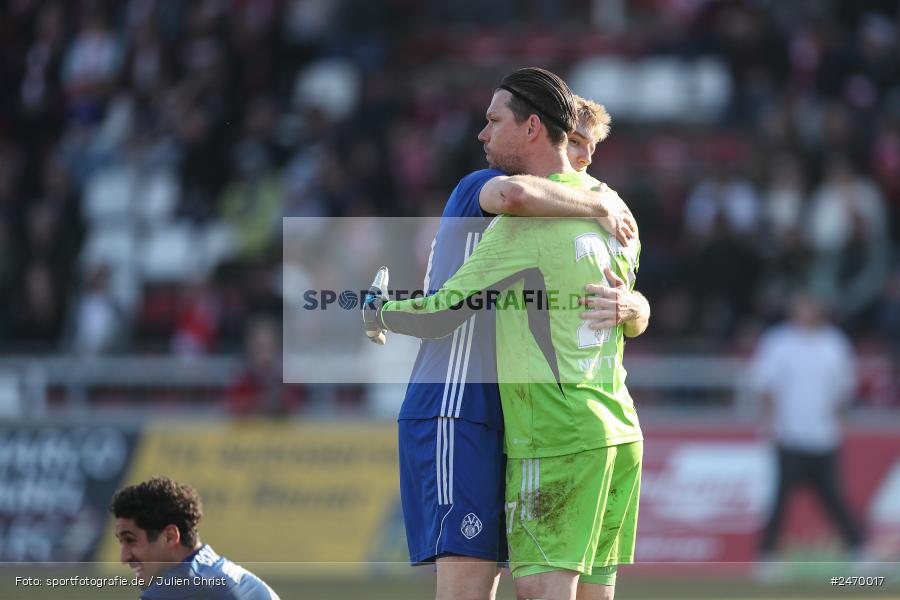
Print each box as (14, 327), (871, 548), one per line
(381, 173), (643, 458)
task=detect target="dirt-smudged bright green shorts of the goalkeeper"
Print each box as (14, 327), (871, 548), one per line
(506, 442), (644, 585)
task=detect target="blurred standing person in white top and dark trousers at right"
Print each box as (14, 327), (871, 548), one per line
(749, 294), (863, 561)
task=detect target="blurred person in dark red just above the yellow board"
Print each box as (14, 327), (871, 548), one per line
(228, 317), (304, 416)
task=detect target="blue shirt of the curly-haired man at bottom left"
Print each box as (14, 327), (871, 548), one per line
(141, 544), (279, 600)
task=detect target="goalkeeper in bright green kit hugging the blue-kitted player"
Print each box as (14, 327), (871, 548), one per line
(369, 76), (643, 600)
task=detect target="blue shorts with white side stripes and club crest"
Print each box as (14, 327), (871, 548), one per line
(397, 417), (508, 565)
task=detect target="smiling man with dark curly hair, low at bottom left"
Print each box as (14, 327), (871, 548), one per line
(109, 476), (278, 600)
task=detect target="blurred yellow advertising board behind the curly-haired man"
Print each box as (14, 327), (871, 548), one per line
(97, 421), (405, 574)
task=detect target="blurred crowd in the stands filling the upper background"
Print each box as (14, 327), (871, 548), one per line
(0, 0), (900, 382)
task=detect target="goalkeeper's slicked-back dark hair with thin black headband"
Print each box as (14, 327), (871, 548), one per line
(497, 67), (578, 144)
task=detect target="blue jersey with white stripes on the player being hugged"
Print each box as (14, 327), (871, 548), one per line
(398, 169), (505, 430)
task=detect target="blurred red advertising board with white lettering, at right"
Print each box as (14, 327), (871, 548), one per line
(636, 424), (900, 563)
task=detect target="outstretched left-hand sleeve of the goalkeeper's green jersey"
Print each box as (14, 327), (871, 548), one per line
(380, 215), (537, 338)
